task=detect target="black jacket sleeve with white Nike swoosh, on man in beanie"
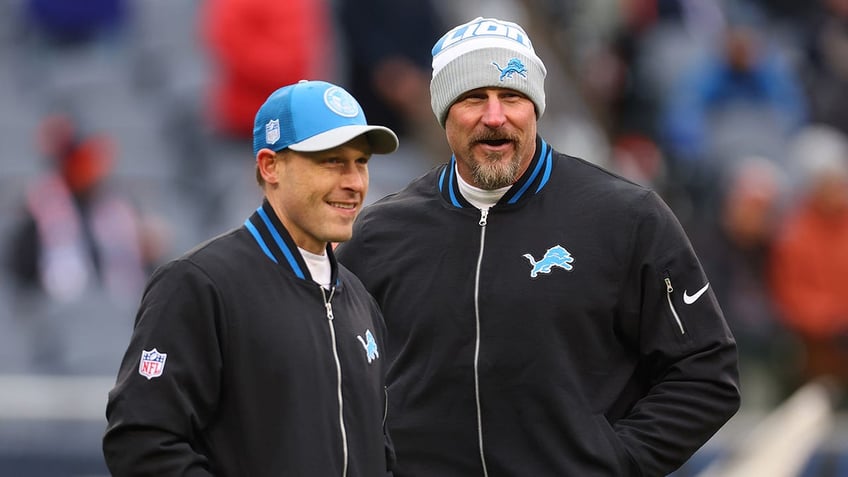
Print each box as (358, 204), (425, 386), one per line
(614, 193), (740, 476)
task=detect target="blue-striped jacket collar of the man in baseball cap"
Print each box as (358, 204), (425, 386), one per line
(244, 199), (338, 285)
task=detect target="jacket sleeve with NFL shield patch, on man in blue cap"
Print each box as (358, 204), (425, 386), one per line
(103, 260), (221, 477)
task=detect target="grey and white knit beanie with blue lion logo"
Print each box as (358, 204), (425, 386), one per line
(430, 17), (547, 127)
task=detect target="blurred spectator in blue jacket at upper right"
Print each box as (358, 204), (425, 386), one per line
(660, 2), (807, 218)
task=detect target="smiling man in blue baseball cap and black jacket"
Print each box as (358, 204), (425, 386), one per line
(103, 81), (398, 477)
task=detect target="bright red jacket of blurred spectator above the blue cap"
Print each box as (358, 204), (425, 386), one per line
(200, 0), (334, 139)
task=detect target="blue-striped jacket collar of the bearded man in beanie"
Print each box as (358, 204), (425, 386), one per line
(438, 136), (553, 208)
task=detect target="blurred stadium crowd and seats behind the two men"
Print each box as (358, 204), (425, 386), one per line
(0, 0), (848, 472)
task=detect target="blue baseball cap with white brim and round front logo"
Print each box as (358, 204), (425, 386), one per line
(253, 80), (398, 156)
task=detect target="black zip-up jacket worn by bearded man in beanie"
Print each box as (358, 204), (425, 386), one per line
(336, 138), (740, 477)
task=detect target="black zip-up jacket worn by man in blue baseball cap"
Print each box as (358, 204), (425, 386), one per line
(103, 201), (392, 477)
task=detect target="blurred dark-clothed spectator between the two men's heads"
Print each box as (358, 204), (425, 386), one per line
(334, 0), (451, 203)
